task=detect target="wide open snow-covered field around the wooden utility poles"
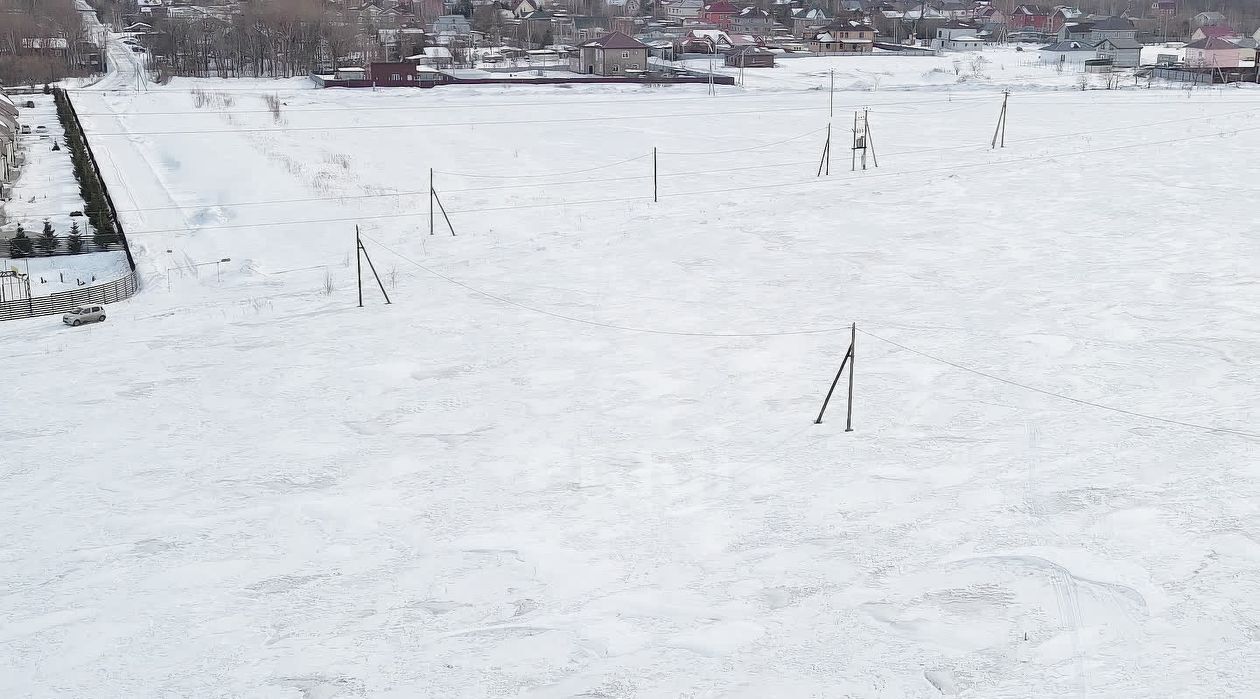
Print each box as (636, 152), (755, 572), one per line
(0, 39), (1260, 698)
